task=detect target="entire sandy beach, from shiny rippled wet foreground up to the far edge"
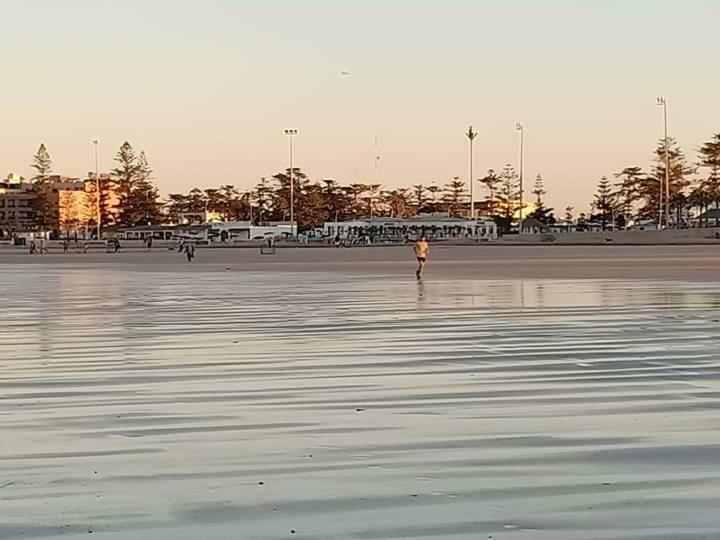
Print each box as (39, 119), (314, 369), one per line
(0, 248), (720, 540)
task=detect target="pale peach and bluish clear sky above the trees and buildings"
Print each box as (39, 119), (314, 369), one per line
(0, 0), (720, 211)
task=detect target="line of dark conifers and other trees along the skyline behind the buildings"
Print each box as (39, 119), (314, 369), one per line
(19, 133), (720, 234)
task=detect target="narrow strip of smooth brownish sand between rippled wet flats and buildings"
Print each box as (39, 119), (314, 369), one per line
(0, 245), (720, 281)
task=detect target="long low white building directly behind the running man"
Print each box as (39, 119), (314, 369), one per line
(322, 216), (497, 243)
